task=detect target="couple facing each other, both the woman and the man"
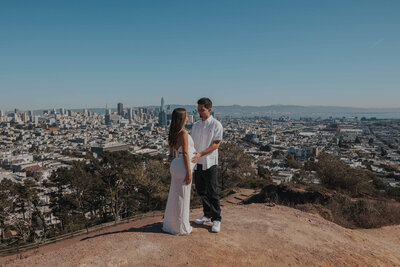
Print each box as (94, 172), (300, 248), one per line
(163, 98), (223, 235)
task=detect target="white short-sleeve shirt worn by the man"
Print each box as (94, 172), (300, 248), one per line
(190, 116), (223, 170)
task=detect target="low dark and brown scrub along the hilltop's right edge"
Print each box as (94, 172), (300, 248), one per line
(245, 184), (400, 228)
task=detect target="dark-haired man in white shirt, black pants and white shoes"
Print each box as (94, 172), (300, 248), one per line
(190, 98), (223, 233)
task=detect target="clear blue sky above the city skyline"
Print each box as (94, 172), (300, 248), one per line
(0, 0), (400, 110)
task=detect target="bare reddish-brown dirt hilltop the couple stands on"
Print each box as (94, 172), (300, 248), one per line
(0, 190), (400, 266)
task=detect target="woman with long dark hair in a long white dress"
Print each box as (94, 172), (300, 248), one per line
(163, 108), (195, 235)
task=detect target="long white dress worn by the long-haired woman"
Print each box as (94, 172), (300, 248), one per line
(162, 135), (195, 235)
